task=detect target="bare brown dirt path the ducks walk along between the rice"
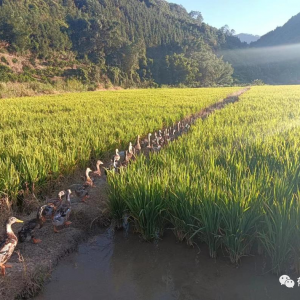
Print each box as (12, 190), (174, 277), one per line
(0, 88), (249, 300)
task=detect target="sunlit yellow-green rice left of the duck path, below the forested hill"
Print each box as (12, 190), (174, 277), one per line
(0, 88), (238, 203)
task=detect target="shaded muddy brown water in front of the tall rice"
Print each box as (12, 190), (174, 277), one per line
(35, 232), (300, 300)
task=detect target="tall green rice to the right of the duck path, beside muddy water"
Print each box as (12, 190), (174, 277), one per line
(108, 86), (300, 274)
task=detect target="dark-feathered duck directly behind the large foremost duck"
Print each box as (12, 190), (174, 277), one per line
(18, 206), (44, 244)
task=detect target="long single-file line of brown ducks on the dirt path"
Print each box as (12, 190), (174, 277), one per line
(0, 118), (195, 275)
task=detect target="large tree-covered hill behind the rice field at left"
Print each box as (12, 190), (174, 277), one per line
(0, 0), (243, 87)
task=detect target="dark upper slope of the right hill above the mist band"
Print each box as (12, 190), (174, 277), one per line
(251, 13), (300, 47)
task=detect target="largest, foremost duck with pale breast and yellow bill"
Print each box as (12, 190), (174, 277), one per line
(0, 217), (23, 276)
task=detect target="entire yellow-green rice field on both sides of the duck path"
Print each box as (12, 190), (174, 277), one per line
(0, 86), (300, 274)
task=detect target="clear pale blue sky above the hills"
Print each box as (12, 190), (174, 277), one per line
(168, 0), (300, 35)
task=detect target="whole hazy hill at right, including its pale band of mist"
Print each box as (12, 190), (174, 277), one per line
(221, 14), (300, 84)
